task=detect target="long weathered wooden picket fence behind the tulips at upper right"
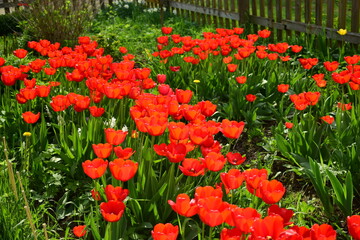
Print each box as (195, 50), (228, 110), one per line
(147, 0), (360, 44)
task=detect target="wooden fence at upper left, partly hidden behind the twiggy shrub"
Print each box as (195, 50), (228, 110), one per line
(0, 0), (113, 14)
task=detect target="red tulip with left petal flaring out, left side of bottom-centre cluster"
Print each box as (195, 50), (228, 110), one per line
(168, 193), (198, 217)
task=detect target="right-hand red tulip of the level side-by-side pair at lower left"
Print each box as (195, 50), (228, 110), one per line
(109, 158), (139, 182)
